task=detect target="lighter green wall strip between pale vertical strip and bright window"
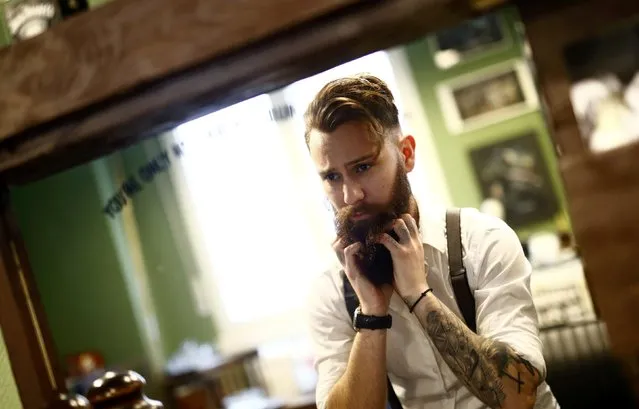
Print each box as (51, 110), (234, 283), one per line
(122, 139), (215, 355)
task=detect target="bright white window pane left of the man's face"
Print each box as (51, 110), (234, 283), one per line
(175, 95), (331, 323)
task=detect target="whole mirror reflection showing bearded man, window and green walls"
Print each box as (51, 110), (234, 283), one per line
(7, 4), (632, 408)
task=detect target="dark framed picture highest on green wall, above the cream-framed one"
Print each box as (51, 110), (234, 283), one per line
(428, 13), (512, 70)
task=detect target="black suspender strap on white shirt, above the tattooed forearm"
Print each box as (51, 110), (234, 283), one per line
(446, 208), (477, 332)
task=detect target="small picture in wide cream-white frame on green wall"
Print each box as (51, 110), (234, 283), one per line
(436, 60), (539, 134)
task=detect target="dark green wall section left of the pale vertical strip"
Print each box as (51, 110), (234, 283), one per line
(12, 165), (144, 367)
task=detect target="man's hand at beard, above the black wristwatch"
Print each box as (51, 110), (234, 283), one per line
(333, 239), (393, 317)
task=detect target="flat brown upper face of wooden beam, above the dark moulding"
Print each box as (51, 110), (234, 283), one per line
(0, 0), (359, 144)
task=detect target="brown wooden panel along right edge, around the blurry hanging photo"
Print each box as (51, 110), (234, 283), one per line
(522, 0), (639, 397)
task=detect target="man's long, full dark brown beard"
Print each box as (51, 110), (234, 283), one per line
(335, 162), (419, 287)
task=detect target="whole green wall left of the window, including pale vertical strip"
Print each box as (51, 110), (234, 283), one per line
(12, 141), (215, 380)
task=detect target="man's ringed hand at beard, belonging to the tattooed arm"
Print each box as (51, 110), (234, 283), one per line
(380, 214), (428, 306)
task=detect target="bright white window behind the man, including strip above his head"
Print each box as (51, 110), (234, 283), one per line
(174, 52), (432, 324)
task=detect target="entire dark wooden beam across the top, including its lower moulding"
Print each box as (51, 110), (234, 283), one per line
(0, 0), (504, 183)
